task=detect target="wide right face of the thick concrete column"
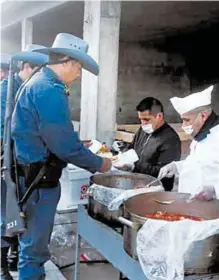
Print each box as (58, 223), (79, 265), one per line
(97, 1), (121, 145)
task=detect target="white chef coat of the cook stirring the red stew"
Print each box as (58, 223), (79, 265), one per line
(176, 125), (219, 198)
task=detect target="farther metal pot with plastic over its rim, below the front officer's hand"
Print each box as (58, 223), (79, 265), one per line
(88, 173), (162, 227)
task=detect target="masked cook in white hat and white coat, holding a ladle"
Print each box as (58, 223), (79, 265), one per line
(158, 86), (219, 200)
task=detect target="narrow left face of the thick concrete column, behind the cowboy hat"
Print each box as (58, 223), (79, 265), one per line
(80, 1), (101, 140)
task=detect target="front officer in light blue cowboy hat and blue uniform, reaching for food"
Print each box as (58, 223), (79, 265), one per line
(12, 33), (112, 280)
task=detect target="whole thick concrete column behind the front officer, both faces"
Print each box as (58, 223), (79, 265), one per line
(81, 1), (121, 145)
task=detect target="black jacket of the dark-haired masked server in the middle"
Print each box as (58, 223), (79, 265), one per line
(130, 123), (181, 191)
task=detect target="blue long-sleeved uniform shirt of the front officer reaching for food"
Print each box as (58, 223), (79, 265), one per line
(11, 67), (103, 172)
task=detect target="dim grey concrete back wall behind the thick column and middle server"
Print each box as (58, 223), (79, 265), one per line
(69, 43), (189, 124)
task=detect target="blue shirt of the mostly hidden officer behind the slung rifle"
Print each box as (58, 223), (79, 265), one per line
(0, 73), (23, 139)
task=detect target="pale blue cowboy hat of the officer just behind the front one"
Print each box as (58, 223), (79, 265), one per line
(12, 44), (48, 65)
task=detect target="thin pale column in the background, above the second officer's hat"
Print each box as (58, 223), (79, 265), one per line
(21, 19), (33, 50)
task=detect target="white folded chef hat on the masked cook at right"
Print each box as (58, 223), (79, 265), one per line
(170, 86), (214, 115)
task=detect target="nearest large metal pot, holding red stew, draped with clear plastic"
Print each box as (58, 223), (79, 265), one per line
(124, 192), (219, 274)
